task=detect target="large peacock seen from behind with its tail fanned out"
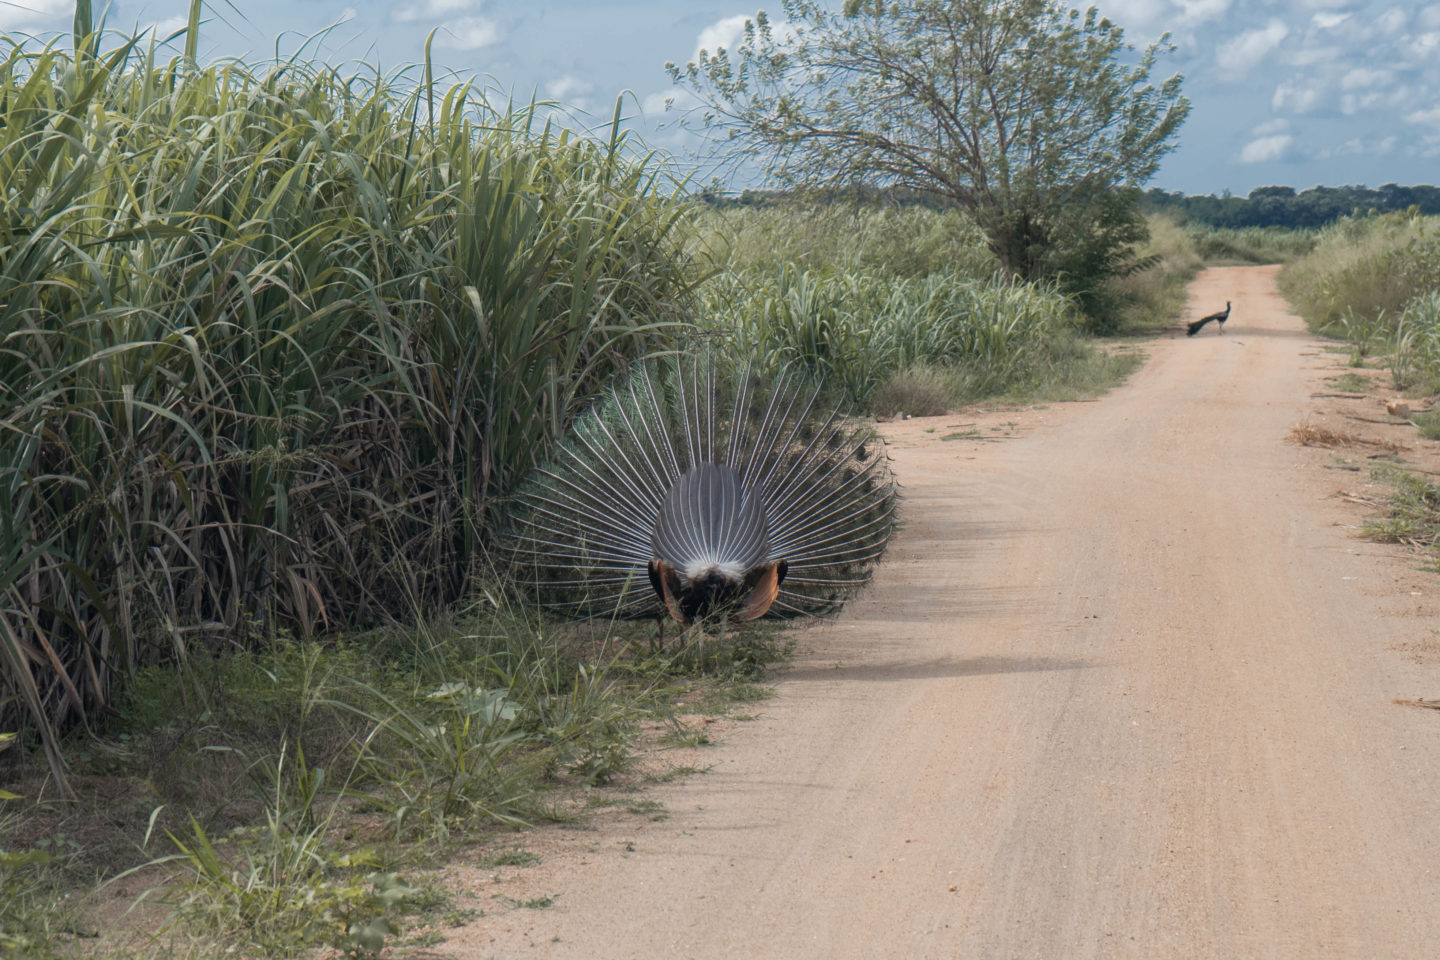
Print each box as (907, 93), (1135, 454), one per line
(504, 357), (896, 623)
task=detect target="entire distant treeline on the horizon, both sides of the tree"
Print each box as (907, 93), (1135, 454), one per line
(698, 183), (1440, 229)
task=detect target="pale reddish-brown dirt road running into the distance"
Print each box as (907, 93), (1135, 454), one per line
(441, 268), (1440, 960)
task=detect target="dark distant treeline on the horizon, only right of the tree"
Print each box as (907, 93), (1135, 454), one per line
(1140, 183), (1440, 229)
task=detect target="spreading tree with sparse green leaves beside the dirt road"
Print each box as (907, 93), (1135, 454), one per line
(665, 0), (1189, 295)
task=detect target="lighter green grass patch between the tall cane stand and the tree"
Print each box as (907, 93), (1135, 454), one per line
(696, 199), (1138, 416)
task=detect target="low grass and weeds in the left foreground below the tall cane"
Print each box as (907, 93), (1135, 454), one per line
(0, 613), (786, 960)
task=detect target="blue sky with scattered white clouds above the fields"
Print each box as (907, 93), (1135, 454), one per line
(0, 0), (1440, 196)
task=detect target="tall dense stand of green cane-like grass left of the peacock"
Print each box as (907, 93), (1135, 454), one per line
(0, 39), (693, 774)
